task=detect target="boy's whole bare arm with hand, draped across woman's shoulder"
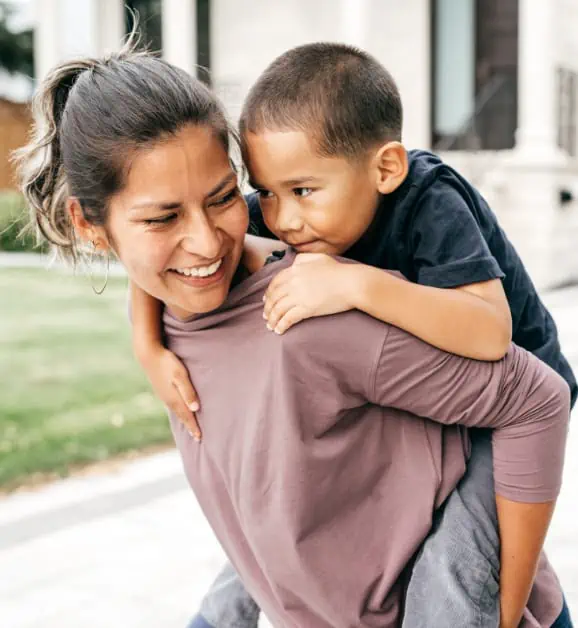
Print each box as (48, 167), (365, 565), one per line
(265, 254), (512, 360)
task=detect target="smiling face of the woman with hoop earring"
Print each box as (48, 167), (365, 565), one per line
(98, 125), (249, 318)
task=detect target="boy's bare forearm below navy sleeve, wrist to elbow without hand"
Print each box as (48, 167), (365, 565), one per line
(352, 264), (512, 360)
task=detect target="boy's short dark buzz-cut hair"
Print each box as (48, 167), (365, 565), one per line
(240, 43), (403, 157)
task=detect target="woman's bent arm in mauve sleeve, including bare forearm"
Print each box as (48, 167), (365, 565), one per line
(368, 327), (570, 628)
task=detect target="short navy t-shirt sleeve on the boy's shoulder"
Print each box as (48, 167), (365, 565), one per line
(410, 179), (504, 288)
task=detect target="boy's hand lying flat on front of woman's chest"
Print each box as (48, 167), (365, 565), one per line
(139, 347), (201, 442)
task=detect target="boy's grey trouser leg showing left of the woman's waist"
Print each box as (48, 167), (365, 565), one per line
(188, 563), (260, 628)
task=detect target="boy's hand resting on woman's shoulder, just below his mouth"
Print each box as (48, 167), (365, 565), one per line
(263, 253), (354, 334)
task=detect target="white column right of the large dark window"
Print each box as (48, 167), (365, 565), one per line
(516, 0), (560, 161)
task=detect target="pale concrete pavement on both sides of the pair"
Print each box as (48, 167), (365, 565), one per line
(0, 289), (578, 628)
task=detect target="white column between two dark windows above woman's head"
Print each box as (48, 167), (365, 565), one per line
(162, 0), (197, 75)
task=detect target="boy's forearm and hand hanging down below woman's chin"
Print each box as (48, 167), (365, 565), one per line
(130, 281), (201, 441)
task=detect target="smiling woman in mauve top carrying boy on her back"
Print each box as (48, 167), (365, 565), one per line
(15, 45), (570, 628)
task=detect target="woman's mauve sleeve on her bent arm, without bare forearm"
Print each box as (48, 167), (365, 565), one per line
(368, 327), (570, 502)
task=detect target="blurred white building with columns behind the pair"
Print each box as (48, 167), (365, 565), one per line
(35, 0), (578, 286)
